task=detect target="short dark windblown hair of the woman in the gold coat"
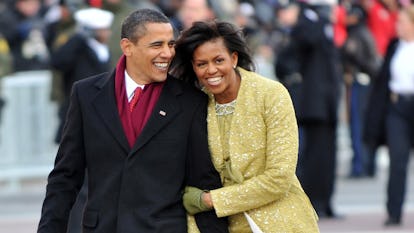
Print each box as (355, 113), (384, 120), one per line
(170, 20), (255, 82)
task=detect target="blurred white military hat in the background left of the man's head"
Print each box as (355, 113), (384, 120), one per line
(74, 8), (114, 30)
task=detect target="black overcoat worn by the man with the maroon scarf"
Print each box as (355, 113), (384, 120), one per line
(38, 72), (225, 233)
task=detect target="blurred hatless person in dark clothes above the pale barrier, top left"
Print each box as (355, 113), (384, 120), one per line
(0, 0), (50, 72)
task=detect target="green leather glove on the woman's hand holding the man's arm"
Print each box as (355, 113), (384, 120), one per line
(183, 186), (211, 215)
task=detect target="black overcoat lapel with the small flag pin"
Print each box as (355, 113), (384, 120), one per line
(130, 77), (182, 155)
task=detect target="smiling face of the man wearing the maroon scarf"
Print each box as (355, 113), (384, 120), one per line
(121, 23), (175, 84)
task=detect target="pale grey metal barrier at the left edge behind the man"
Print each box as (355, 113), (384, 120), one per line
(0, 71), (57, 192)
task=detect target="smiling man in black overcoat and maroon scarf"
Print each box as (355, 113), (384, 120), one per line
(38, 9), (227, 233)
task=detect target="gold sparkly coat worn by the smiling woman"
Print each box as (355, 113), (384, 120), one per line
(207, 68), (319, 233)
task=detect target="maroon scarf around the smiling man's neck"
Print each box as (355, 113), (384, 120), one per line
(115, 55), (165, 148)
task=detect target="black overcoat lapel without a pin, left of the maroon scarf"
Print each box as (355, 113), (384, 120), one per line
(93, 72), (129, 154)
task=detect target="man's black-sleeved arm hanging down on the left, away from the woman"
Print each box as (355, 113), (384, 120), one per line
(37, 83), (85, 233)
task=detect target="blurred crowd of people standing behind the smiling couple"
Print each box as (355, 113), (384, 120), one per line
(0, 0), (414, 228)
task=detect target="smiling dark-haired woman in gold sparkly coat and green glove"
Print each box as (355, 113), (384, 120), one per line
(172, 21), (319, 233)
